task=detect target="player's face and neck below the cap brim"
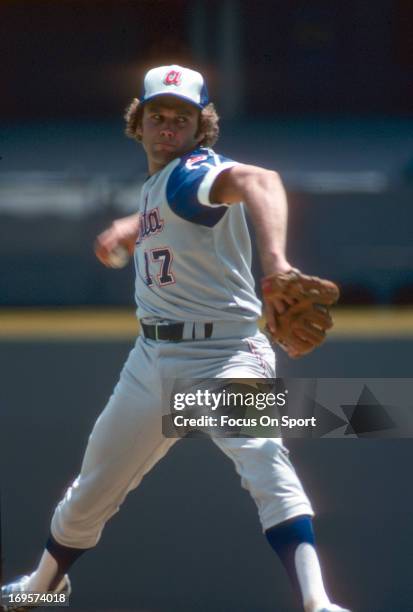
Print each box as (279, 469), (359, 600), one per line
(139, 96), (203, 174)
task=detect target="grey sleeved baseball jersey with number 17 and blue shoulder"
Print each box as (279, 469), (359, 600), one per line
(135, 148), (261, 322)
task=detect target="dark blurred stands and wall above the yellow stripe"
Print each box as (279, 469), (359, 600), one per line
(0, 0), (413, 306)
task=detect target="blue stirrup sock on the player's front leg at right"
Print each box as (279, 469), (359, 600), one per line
(265, 515), (315, 599)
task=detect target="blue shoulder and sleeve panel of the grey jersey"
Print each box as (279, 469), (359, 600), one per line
(166, 148), (231, 227)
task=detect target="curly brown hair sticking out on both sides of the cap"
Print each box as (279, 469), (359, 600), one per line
(124, 98), (219, 147)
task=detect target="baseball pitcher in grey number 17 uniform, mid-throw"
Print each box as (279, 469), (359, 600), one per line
(2, 65), (348, 612)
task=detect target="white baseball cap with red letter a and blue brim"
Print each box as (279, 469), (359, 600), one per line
(141, 64), (209, 108)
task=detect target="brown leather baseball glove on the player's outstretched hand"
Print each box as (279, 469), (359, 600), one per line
(262, 268), (340, 357)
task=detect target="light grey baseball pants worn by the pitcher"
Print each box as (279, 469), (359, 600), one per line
(51, 323), (313, 549)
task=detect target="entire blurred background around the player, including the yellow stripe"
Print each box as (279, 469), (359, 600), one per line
(0, 0), (413, 612)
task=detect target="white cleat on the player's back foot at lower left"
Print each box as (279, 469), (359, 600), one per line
(0, 575), (72, 612)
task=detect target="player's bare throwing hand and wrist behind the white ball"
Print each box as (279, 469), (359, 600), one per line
(94, 214), (139, 268)
